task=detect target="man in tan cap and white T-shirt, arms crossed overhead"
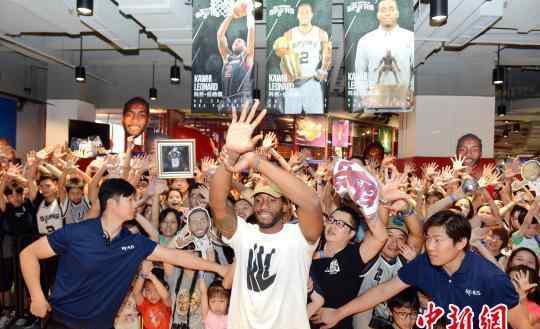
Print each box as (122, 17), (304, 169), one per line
(210, 101), (323, 329)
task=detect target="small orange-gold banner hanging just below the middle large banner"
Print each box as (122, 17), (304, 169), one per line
(296, 116), (328, 147)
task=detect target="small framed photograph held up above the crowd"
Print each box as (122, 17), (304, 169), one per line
(157, 139), (196, 178)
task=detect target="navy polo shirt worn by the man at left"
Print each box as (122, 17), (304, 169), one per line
(47, 218), (156, 329)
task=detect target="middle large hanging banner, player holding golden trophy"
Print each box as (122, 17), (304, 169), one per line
(266, 0), (332, 114)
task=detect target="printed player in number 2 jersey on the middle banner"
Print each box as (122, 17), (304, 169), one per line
(273, 3), (332, 114)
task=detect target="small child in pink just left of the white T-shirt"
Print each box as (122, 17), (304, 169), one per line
(199, 280), (229, 329)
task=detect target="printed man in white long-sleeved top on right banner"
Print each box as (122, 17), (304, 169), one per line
(355, 0), (414, 107)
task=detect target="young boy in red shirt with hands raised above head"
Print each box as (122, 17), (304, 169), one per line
(133, 261), (171, 329)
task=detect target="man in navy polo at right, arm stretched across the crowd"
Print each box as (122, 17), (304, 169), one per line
(317, 210), (530, 329)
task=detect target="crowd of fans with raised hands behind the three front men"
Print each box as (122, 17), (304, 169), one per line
(0, 107), (540, 329)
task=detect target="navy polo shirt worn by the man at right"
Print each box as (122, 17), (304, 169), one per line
(398, 251), (519, 318)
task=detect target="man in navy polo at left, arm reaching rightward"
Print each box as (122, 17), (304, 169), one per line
(20, 179), (227, 329)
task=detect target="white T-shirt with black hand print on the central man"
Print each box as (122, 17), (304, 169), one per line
(225, 218), (317, 329)
